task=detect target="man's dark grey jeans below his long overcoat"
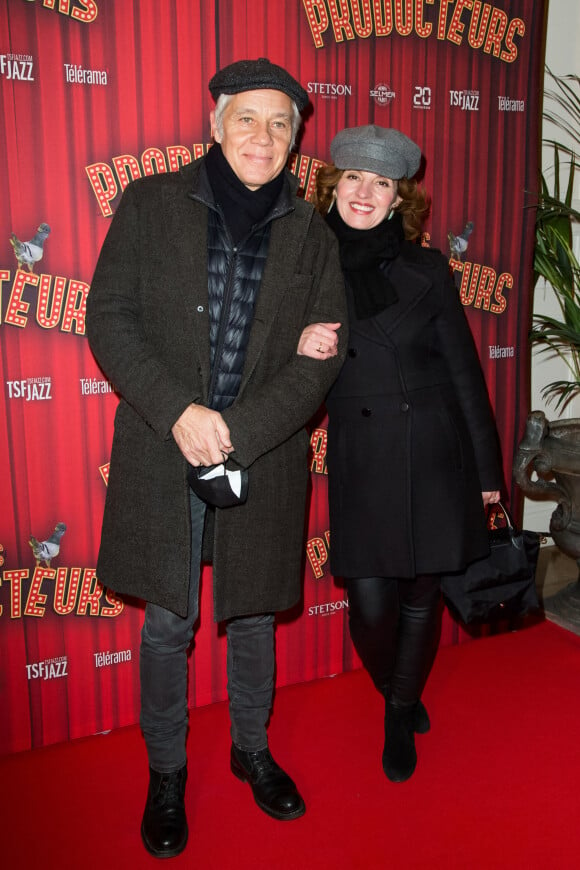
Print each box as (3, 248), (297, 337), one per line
(140, 493), (275, 773)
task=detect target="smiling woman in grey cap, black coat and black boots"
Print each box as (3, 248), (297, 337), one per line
(299, 125), (502, 782)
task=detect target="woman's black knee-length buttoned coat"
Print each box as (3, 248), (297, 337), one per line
(327, 242), (502, 578)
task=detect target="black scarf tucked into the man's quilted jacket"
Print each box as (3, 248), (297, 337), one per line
(205, 142), (284, 244)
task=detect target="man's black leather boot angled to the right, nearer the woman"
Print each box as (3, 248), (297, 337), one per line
(230, 744), (306, 822)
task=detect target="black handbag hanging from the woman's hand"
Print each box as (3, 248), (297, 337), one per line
(441, 502), (540, 623)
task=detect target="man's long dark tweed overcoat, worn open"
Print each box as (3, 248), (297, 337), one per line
(87, 161), (347, 620)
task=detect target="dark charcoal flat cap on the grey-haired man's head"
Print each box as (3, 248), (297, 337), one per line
(209, 57), (309, 112)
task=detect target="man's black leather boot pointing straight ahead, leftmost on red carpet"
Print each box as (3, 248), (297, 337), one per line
(141, 767), (188, 858)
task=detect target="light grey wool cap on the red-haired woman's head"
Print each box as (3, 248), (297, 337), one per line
(330, 124), (421, 180)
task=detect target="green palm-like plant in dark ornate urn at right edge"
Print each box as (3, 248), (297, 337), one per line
(514, 68), (580, 624)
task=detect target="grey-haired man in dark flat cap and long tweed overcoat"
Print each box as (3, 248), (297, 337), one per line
(87, 58), (346, 857)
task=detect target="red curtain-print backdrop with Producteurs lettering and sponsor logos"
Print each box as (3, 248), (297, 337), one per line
(0, 0), (544, 752)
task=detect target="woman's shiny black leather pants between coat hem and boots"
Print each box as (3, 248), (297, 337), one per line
(347, 574), (441, 707)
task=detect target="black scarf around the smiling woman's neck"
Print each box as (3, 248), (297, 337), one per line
(326, 205), (405, 320)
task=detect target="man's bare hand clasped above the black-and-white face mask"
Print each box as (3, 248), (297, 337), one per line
(171, 405), (234, 466)
